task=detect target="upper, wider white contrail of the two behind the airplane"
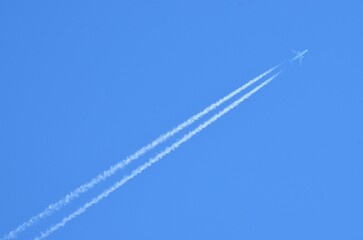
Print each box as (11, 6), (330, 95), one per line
(2, 64), (281, 240)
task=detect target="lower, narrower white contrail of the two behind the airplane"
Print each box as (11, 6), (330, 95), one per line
(34, 72), (281, 240)
